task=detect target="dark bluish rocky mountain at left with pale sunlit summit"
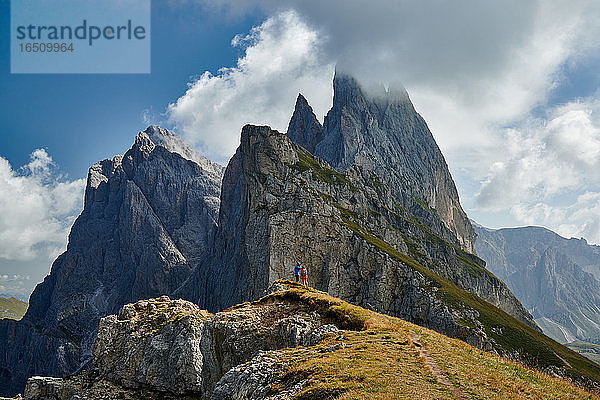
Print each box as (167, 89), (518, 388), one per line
(0, 127), (222, 393)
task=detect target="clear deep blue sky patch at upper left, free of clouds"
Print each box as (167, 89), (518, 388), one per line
(0, 0), (261, 177)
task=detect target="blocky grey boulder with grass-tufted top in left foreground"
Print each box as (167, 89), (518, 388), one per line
(94, 296), (211, 395)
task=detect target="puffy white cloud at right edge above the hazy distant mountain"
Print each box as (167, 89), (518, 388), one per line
(477, 100), (600, 208)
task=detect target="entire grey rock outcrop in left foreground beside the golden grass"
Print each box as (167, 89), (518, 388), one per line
(19, 296), (340, 400)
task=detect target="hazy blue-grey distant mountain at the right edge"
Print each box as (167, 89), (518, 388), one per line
(476, 225), (600, 343)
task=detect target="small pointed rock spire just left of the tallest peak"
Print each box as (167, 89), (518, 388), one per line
(287, 94), (324, 153)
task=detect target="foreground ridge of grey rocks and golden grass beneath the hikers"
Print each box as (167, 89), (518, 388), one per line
(18, 281), (600, 400)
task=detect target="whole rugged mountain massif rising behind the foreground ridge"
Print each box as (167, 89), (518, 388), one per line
(0, 73), (600, 394)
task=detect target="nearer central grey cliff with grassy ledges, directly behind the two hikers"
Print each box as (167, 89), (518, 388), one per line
(176, 125), (535, 347)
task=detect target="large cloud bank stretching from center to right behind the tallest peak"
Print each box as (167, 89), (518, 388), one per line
(169, 0), (600, 243)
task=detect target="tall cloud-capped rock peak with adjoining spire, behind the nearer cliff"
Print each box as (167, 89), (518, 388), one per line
(287, 72), (475, 253)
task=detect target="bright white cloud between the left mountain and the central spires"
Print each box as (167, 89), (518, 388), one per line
(168, 11), (334, 161)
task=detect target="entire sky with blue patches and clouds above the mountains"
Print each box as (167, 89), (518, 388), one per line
(0, 0), (600, 298)
